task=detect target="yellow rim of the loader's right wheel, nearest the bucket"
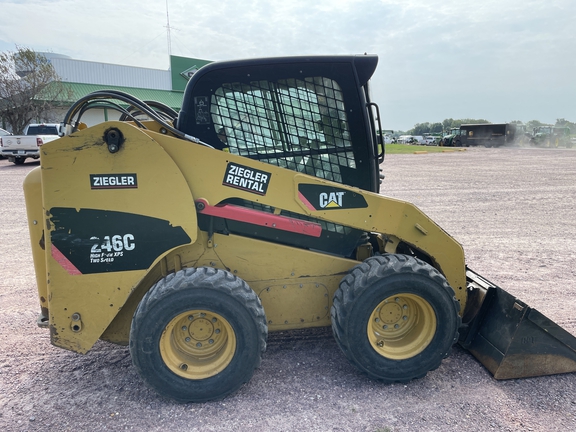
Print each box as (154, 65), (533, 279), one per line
(367, 294), (436, 360)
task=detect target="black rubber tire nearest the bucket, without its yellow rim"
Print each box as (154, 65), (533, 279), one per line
(331, 254), (461, 383)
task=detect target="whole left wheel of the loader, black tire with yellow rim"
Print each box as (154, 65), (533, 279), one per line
(130, 267), (268, 402)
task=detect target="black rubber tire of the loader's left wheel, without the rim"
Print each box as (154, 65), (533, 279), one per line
(130, 267), (268, 403)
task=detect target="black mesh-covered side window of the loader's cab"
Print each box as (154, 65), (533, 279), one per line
(210, 77), (356, 183)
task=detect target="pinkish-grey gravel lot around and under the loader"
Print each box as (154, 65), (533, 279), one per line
(0, 148), (576, 432)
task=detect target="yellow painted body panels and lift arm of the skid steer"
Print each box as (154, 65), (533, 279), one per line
(31, 122), (466, 353)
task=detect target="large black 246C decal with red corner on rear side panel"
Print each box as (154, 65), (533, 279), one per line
(50, 207), (190, 275)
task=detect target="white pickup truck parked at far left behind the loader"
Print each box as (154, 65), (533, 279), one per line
(0, 123), (60, 165)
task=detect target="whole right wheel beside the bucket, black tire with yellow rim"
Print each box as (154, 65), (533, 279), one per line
(331, 255), (461, 382)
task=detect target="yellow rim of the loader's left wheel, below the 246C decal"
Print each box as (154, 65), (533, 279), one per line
(160, 310), (236, 380)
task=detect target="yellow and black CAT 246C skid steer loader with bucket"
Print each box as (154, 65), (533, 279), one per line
(24, 55), (576, 402)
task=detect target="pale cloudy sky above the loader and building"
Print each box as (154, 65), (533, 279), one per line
(0, 0), (576, 130)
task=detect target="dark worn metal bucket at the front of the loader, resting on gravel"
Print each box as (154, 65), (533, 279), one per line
(460, 270), (576, 379)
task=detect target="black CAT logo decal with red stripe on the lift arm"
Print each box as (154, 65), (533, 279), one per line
(298, 183), (368, 211)
